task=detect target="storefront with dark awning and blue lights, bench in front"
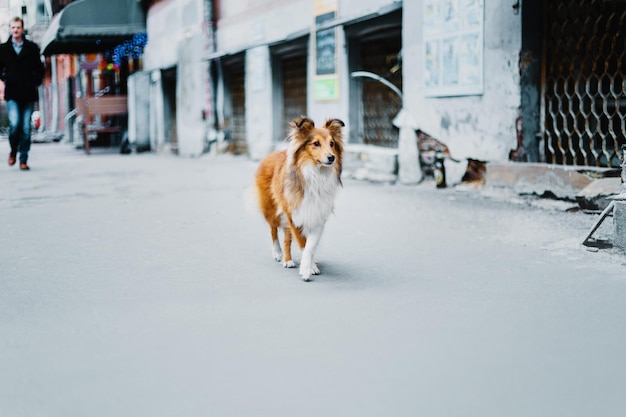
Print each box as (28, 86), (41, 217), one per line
(41, 0), (147, 150)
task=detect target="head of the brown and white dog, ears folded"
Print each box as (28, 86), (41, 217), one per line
(291, 118), (345, 167)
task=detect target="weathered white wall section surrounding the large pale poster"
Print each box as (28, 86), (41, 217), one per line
(403, 0), (521, 160)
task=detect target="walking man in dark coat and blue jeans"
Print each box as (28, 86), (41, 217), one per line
(0, 17), (44, 171)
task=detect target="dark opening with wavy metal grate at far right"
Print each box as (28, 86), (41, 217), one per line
(544, 0), (626, 167)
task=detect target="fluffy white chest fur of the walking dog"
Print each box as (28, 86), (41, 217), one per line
(292, 165), (339, 236)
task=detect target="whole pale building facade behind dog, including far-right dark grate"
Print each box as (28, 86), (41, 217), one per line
(33, 0), (626, 180)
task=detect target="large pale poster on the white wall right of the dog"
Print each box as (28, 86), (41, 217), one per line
(422, 0), (484, 97)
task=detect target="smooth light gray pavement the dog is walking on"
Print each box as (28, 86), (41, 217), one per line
(0, 141), (626, 417)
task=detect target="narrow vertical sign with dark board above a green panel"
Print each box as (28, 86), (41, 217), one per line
(313, 0), (339, 100)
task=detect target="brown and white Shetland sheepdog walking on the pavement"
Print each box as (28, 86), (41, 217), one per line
(256, 117), (345, 281)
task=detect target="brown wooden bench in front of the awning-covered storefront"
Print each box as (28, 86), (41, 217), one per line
(76, 96), (128, 154)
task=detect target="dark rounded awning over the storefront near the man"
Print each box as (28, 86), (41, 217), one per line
(41, 0), (146, 55)
